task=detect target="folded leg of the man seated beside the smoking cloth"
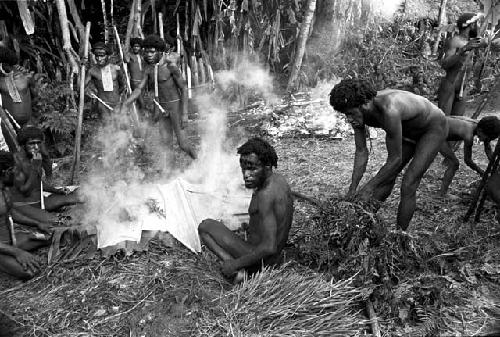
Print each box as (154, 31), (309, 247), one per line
(198, 219), (253, 261)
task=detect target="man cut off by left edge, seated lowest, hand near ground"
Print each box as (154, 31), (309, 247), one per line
(0, 183), (51, 280)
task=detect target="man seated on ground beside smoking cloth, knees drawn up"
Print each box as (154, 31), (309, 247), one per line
(198, 138), (293, 277)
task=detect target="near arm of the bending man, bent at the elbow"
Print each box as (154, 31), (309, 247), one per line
(363, 111), (403, 194)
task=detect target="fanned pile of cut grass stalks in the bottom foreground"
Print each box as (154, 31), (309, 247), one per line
(197, 266), (366, 337)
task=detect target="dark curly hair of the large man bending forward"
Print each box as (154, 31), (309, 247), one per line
(330, 79), (377, 111)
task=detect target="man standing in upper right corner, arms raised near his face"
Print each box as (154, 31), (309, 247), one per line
(438, 13), (487, 116)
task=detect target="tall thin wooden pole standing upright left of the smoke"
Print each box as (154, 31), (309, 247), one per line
(69, 22), (90, 185)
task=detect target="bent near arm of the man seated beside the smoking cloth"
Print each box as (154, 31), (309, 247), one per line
(229, 191), (278, 271)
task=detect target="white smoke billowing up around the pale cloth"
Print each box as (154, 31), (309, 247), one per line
(81, 56), (276, 246)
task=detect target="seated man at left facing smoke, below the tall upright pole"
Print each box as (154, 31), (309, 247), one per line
(12, 126), (81, 221)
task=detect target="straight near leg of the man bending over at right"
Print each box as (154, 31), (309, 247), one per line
(396, 124), (448, 230)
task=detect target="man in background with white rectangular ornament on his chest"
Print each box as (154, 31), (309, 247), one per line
(85, 42), (126, 116)
